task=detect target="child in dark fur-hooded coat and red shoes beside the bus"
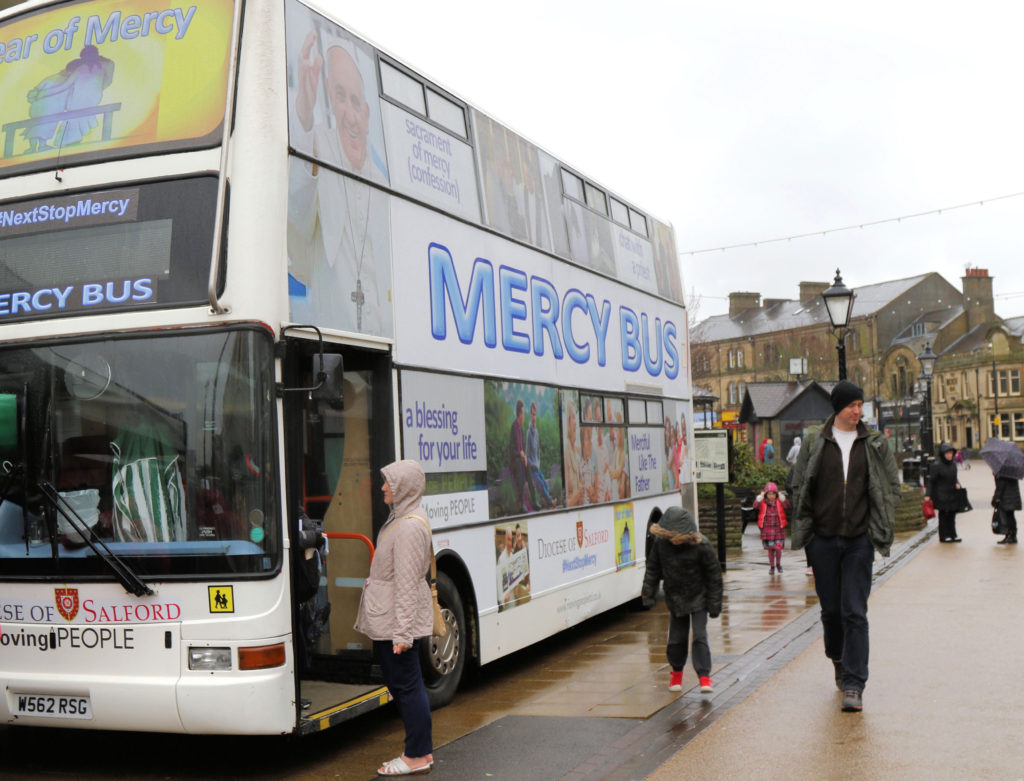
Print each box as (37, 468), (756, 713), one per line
(641, 507), (722, 693)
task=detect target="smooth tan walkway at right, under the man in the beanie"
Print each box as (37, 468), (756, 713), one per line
(647, 463), (1024, 781)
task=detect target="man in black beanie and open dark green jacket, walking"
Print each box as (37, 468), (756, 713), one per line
(792, 380), (900, 712)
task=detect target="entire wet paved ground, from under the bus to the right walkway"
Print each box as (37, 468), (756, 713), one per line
(6, 463), (1024, 781)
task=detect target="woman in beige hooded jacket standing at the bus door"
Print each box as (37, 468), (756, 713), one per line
(355, 460), (433, 776)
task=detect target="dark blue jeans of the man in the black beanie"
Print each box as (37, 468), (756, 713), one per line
(807, 534), (874, 691)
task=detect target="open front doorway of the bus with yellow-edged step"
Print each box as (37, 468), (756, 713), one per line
(282, 339), (393, 733)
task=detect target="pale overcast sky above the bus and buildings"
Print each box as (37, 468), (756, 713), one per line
(318, 0), (1024, 319)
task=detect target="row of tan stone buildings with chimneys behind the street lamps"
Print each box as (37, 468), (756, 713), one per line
(690, 268), (1024, 447)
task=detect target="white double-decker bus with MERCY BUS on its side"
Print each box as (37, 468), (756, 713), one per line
(0, 0), (695, 734)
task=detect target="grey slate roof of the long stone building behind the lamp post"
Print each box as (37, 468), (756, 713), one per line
(693, 272), (933, 342)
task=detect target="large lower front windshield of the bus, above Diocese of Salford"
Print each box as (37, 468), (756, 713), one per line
(0, 330), (281, 579)
